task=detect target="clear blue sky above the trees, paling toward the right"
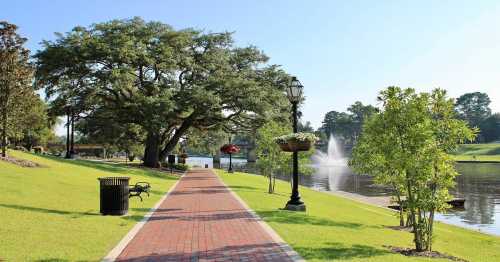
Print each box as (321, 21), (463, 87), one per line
(0, 0), (500, 133)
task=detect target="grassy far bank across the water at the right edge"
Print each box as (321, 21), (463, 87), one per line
(454, 143), (500, 162)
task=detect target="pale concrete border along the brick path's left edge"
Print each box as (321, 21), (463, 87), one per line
(101, 172), (187, 262)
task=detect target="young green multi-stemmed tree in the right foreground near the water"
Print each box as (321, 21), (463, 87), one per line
(350, 87), (477, 251)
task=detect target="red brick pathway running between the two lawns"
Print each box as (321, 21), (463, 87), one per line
(117, 169), (293, 261)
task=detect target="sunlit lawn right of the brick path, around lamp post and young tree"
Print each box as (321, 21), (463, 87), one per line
(217, 170), (500, 261)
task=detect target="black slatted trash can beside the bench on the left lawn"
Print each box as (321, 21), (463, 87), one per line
(98, 177), (130, 216)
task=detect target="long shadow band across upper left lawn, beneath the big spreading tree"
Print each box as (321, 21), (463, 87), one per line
(31, 155), (177, 180)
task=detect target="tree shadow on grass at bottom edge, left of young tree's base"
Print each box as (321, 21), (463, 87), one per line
(294, 242), (392, 261)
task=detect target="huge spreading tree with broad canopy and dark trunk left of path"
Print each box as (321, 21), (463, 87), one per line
(35, 18), (288, 166)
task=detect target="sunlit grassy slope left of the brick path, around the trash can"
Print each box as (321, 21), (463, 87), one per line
(0, 151), (176, 261)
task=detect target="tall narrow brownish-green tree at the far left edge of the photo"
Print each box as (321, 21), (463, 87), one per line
(0, 21), (33, 157)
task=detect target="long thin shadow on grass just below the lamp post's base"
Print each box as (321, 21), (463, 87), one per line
(257, 210), (363, 228)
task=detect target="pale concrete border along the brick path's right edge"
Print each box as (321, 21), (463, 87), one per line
(211, 169), (306, 262)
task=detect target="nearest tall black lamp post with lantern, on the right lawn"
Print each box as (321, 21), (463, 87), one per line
(285, 77), (306, 211)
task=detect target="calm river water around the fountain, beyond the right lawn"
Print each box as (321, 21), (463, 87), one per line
(188, 157), (500, 236)
